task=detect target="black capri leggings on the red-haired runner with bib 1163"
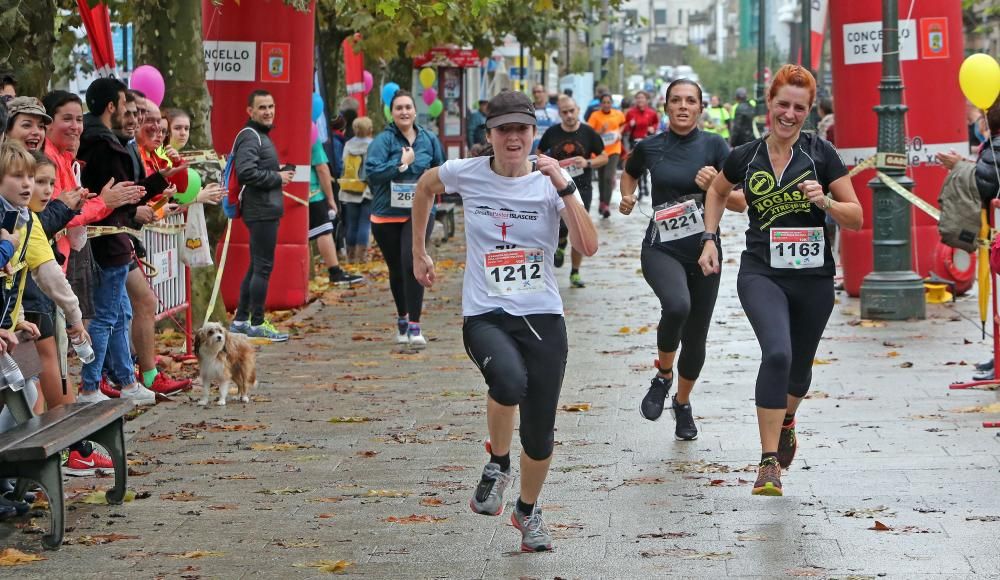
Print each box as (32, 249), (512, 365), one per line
(736, 271), (833, 409)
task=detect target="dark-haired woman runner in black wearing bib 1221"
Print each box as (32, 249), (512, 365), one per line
(619, 79), (746, 441)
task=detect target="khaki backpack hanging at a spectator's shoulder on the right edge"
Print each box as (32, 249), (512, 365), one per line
(938, 162), (983, 253)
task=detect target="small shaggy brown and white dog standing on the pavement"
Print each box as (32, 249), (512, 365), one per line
(194, 322), (257, 406)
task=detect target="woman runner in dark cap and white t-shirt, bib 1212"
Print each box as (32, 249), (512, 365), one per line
(412, 91), (597, 552)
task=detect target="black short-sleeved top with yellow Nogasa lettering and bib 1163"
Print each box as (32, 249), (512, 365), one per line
(722, 133), (847, 277)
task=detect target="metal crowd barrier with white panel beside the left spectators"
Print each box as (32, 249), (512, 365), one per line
(142, 208), (194, 355)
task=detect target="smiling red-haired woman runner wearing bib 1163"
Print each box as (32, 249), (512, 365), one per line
(698, 64), (862, 495)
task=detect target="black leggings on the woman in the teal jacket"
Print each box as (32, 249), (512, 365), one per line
(372, 217), (434, 322)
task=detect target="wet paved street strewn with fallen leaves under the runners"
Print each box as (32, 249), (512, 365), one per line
(0, 202), (1000, 579)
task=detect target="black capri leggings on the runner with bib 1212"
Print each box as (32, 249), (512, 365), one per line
(462, 310), (568, 461)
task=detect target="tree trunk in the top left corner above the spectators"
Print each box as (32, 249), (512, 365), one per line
(0, 0), (56, 97)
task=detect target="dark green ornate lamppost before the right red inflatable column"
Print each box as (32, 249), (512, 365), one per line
(861, 0), (927, 320)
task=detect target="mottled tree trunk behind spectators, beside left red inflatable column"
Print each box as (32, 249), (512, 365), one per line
(133, 0), (226, 328)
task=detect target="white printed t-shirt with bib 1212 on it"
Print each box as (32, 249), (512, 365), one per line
(438, 157), (566, 316)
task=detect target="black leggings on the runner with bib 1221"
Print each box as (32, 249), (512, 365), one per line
(641, 243), (720, 381)
